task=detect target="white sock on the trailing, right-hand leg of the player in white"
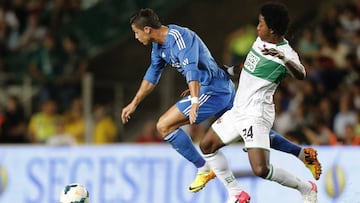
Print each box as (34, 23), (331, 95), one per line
(266, 165), (312, 194)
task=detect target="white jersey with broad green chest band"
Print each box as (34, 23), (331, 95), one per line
(232, 37), (300, 126)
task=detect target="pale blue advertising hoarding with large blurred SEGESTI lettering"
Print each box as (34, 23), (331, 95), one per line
(0, 144), (360, 203)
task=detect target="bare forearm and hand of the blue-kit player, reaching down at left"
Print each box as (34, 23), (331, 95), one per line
(121, 80), (155, 124)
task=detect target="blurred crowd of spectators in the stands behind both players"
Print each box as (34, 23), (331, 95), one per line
(0, 0), (360, 145)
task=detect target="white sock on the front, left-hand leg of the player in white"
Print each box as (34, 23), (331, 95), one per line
(205, 151), (242, 196)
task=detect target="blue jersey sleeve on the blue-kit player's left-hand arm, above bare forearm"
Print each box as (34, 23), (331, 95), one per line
(143, 45), (166, 84)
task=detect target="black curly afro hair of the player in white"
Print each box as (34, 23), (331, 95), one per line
(260, 2), (290, 36)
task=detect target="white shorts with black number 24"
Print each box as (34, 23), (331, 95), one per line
(211, 109), (271, 150)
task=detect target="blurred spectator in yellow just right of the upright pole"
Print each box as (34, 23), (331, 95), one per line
(93, 105), (118, 144)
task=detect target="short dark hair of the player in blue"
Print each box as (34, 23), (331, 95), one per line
(130, 8), (161, 29)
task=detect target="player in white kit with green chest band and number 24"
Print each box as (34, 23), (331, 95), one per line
(200, 2), (317, 203)
